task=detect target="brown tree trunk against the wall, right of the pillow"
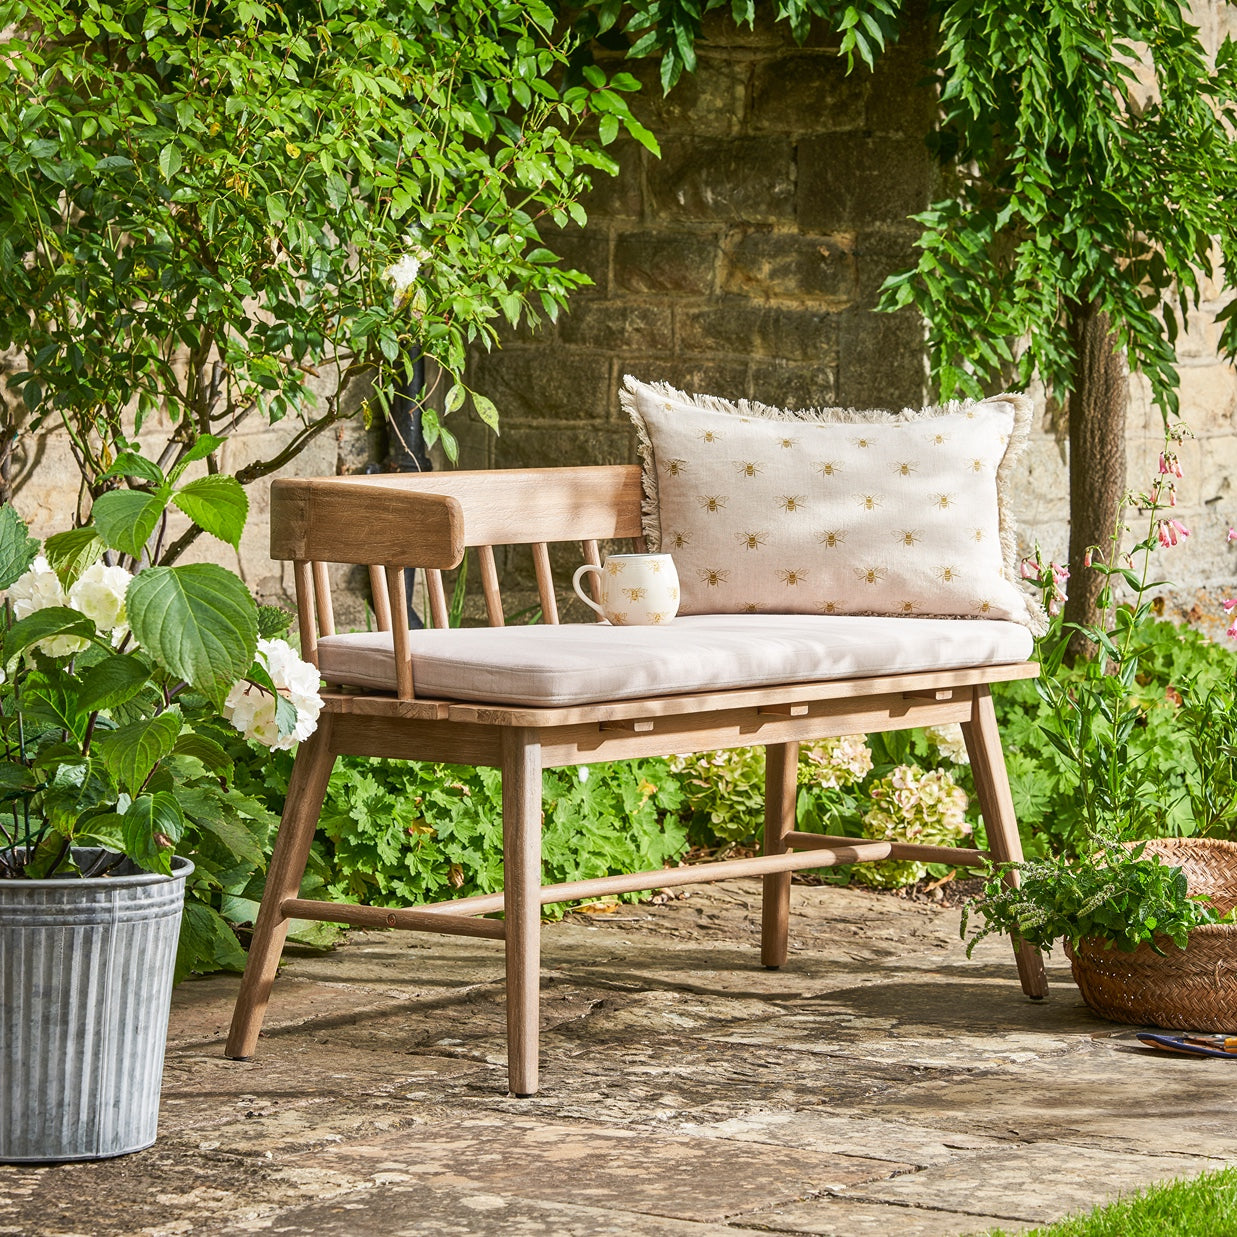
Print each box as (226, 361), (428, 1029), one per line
(1065, 301), (1129, 657)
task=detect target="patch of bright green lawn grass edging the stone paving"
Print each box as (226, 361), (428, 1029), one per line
(987, 1168), (1237, 1237)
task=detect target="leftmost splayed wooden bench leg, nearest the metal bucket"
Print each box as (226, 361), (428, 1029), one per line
(224, 713), (335, 1060)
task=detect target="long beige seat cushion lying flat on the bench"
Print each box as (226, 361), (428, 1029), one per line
(318, 615), (1032, 706)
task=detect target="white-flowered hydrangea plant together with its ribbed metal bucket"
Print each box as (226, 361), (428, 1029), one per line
(0, 439), (322, 1160)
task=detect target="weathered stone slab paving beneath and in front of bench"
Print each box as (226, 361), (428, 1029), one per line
(0, 882), (1237, 1237)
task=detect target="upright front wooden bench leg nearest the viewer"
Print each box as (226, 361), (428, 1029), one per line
(502, 730), (542, 1097)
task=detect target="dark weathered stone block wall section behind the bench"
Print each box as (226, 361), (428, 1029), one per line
(465, 10), (933, 477)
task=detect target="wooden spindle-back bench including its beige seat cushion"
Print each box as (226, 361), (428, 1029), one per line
(226, 466), (1047, 1096)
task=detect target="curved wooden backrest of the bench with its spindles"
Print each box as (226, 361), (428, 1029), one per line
(271, 465), (643, 698)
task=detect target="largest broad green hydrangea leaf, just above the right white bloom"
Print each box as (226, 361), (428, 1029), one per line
(125, 563), (257, 705)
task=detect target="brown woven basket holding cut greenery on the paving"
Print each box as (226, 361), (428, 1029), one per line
(1065, 837), (1237, 1032)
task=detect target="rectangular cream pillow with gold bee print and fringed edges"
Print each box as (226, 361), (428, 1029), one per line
(621, 377), (1045, 631)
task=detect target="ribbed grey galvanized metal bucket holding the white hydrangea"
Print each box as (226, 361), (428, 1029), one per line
(0, 850), (193, 1163)
